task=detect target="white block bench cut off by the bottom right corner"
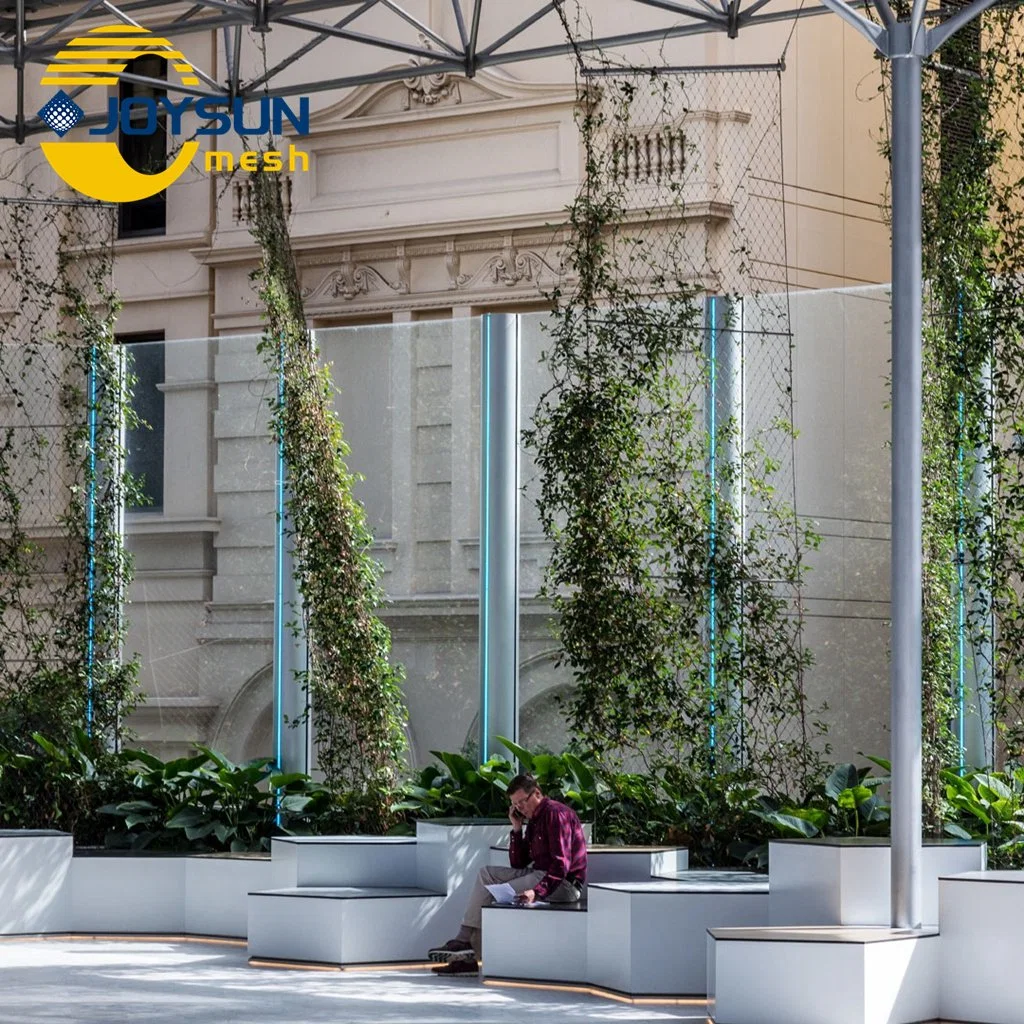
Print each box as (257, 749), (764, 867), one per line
(939, 871), (1024, 1024)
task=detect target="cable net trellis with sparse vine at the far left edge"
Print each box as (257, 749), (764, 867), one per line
(0, 199), (132, 746)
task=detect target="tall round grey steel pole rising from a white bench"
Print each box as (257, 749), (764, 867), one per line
(890, 39), (922, 928)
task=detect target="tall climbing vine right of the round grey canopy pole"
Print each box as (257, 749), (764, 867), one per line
(872, 10), (1024, 834)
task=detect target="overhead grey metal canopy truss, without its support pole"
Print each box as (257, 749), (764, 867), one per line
(0, 0), (863, 142)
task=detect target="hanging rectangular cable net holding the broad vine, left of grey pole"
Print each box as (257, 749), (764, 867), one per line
(529, 65), (819, 790)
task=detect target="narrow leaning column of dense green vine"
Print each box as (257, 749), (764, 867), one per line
(245, 161), (406, 830)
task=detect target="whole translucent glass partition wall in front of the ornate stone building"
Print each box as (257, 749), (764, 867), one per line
(116, 288), (925, 767)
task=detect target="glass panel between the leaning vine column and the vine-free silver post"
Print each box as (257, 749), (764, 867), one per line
(315, 319), (480, 766)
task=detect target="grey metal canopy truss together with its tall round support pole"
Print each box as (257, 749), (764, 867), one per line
(0, 0), (1016, 928)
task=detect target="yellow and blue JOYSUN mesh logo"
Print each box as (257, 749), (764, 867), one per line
(39, 25), (309, 203)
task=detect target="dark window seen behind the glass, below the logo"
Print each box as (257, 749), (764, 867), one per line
(120, 334), (164, 512)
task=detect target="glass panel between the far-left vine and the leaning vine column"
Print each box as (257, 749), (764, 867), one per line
(125, 335), (276, 759)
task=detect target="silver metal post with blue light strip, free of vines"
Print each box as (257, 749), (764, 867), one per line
(480, 313), (519, 761)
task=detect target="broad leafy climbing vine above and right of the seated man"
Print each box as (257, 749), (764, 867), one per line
(525, 73), (823, 793)
